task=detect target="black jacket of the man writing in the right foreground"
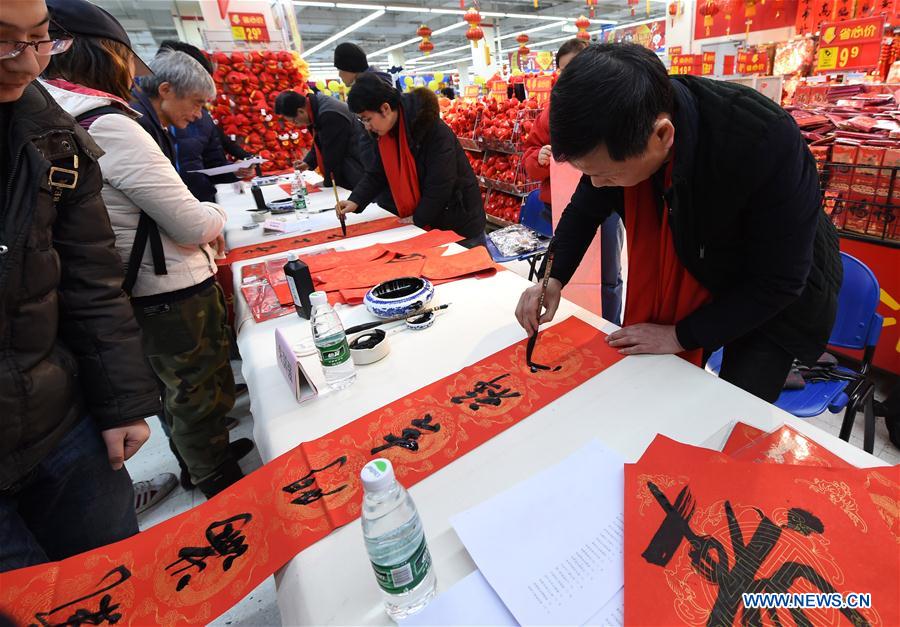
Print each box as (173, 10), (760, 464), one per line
(550, 76), (843, 362)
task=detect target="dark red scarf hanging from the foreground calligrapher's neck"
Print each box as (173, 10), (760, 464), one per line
(623, 162), (711, 366)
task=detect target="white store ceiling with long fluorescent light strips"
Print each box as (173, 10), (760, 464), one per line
(93, 0), (667, 68)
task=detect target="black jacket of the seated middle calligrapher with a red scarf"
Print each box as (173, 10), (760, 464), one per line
(350, 88), (485, 238)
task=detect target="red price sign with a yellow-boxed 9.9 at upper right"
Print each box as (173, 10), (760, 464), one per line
(816, 16), (884, 72)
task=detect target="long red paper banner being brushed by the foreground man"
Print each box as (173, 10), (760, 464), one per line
(0, 318), (622, 626)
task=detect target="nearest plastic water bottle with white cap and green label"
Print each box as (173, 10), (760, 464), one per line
(360, 459), (437, 621)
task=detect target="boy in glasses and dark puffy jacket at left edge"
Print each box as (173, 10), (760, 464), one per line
(0, 0), (160, 571)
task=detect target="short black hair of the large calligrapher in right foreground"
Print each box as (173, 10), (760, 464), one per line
(550, 43), (674, 161)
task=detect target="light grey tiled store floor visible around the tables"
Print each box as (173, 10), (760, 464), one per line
(128, 356), (900, 627)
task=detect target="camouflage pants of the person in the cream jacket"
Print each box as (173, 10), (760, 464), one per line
(134, 284), (234, 484)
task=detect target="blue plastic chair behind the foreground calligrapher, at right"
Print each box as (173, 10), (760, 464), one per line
(706, 253), (884, 453)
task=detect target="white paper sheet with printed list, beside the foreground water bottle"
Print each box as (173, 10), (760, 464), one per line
(450, 440), (624, 625)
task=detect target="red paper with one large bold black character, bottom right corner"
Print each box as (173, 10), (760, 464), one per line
(625, 436), (900, 626)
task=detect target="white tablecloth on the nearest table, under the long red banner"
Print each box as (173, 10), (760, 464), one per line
(229, 227), (883, 625)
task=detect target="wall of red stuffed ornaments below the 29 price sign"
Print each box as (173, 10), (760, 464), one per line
(210, 51), (312, 172)
